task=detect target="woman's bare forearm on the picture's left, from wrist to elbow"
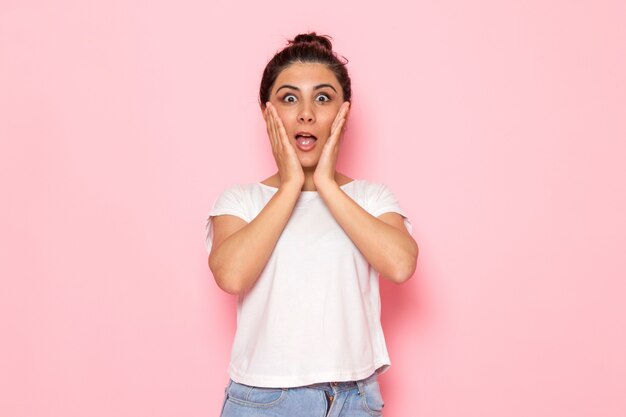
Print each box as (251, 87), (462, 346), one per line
(209, 186), (300, 294)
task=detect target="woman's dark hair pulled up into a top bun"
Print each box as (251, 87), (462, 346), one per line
(259, 32), (352, 107)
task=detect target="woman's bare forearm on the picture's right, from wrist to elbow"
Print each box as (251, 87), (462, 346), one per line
(318, 183), (418, 283)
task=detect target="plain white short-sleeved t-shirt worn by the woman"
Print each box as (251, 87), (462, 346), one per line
(206, 180), (412, 388)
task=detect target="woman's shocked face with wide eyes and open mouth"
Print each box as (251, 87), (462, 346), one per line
(262, 63), (343, 168)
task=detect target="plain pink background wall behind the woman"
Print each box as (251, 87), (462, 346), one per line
(0, 0), (626, 417)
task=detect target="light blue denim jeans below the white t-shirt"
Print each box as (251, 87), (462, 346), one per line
(220, 373), (384, 417)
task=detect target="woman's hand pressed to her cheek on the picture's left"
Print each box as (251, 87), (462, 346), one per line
(263, 101), (304, 189)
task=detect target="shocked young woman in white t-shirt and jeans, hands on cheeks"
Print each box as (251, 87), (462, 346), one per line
(206, 32), (418, 417)
